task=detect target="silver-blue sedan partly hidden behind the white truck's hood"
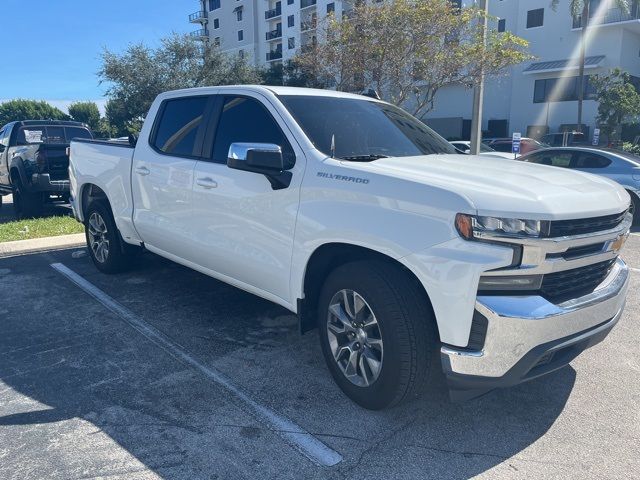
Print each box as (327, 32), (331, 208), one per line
(521, 147), (640, 225)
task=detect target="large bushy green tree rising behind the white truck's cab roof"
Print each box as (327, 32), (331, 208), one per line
(98, 34), (260, 135)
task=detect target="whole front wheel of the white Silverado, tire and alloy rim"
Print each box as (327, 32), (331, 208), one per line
(318, 261), (438, 410)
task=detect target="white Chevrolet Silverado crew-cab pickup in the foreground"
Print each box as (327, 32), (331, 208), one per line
(70, 86), (631, 409)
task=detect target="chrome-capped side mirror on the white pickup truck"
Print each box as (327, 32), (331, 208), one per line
(227, 143), (292, 190)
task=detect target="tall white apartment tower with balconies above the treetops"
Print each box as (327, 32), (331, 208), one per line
(189, 0), (351, 66)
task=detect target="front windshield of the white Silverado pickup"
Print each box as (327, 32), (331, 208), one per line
(280, 95), (458, 160)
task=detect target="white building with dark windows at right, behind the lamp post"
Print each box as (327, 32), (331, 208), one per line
(425, 0), (640, 139)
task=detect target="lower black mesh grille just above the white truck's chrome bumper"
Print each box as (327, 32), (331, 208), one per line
(540, 258), (616, 303)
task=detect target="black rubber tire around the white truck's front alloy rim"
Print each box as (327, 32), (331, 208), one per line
(318, 260), (439, 410)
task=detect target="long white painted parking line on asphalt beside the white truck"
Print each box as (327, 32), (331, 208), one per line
(51, 263), (342, 466)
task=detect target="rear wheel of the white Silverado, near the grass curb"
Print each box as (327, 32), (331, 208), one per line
(84, 200), (133, 273)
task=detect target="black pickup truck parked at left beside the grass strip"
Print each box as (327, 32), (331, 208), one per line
(0, 120), (93, 218)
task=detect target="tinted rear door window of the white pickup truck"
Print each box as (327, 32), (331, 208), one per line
(153, 97), (207, 156)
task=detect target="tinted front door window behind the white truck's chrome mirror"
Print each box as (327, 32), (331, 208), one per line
(213, 97), (295, 167)
